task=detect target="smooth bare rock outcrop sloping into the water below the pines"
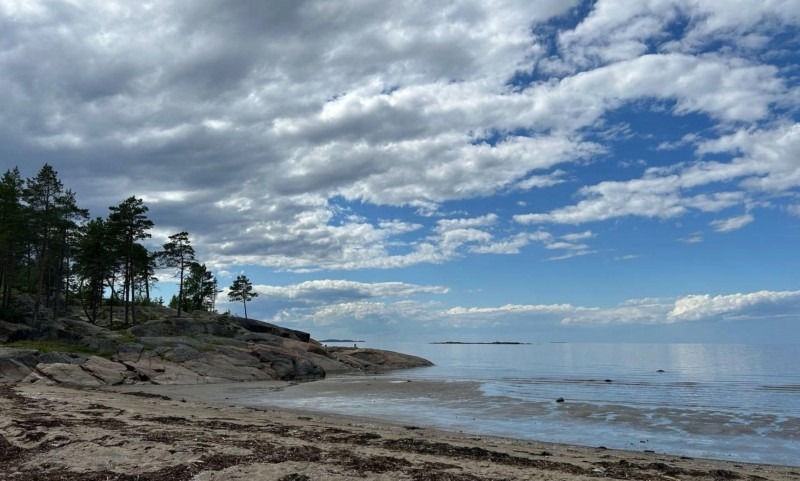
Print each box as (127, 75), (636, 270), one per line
(0, 308), (431, 387)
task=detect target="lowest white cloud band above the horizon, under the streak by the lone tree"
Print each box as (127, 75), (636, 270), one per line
(283, 291), (800, 335)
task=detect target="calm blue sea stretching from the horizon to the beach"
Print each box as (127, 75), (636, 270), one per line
(233, 342), (800, 466)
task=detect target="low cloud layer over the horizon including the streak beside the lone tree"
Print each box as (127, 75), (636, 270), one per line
(221, 280), (800, 340)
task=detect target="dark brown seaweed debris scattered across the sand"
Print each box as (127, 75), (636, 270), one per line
(0, 385), (788, 481)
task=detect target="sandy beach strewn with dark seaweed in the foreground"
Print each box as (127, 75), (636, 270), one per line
(0, 382), (800, 481)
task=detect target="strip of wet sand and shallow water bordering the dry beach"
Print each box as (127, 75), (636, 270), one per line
(114, 373), (800, 467)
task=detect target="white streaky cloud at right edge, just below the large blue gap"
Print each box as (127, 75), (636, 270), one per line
(514, 124), (800, 230)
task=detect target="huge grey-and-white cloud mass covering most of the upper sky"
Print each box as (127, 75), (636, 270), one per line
(0, 0), (800, 272)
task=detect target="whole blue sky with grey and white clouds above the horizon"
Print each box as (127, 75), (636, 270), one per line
(0, 0), (800, 343)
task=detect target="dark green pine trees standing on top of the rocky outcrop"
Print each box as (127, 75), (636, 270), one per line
(0, 164), (257, 327)
